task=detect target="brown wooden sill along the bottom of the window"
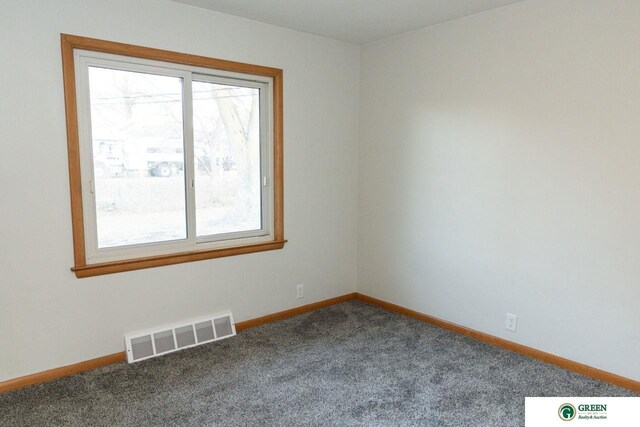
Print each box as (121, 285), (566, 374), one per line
(71, 240), (287, 278)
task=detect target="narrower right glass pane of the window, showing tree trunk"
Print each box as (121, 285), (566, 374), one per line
(193, 81), (262, 237)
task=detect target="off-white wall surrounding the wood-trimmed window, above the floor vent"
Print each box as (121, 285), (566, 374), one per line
(0, 0), (359, 381)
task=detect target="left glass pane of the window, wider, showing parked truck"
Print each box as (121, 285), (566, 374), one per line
(89, 66), (187, 248)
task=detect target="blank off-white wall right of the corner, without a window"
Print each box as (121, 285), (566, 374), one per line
(358, 0), (640, 380)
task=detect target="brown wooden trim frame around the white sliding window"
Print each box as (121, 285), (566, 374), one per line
(61, 34), (286, 278)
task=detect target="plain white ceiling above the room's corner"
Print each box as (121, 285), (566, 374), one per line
(172, 0), (522, 45)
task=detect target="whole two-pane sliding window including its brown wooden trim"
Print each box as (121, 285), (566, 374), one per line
(62, 35), (285, 277)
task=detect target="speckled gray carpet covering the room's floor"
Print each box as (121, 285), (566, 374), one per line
(0, 301), (636, 427)
